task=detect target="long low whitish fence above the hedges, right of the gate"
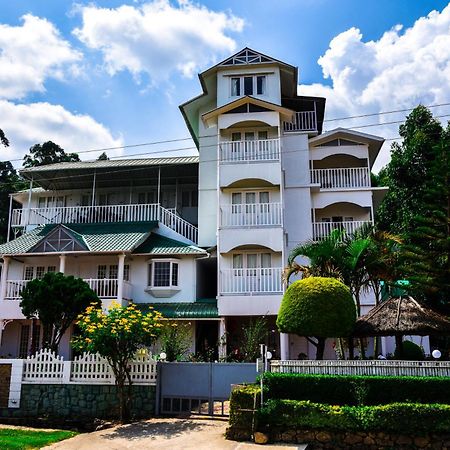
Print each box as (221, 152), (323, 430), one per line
(270, 359), (450, 377)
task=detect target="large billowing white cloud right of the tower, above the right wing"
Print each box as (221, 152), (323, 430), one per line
(299, 5), (450, 169)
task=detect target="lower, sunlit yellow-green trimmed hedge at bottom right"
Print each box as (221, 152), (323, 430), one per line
(257, 399), (450, 435)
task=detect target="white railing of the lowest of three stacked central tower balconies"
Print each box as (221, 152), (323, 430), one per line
(220, 267), (283, 295)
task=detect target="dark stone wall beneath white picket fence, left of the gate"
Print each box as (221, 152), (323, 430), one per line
(0, 384), (156, 421)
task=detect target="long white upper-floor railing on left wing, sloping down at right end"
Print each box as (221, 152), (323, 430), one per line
(11, 203), (197, 243)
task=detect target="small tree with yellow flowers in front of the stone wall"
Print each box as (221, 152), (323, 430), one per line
(72, 303), (163, 421)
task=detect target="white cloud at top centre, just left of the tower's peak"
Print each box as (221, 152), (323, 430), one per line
(74, 0), (244, 82)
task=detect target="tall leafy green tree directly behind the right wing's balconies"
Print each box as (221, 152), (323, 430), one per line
(376, 105), (443, 235)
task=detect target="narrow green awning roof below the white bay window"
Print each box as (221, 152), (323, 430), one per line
(136, 299), (219, 319)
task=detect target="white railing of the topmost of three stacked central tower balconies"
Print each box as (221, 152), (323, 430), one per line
(219, 139), (280, 163)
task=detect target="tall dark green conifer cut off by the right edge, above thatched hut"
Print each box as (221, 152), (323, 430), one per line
(404, 132), (450, 313)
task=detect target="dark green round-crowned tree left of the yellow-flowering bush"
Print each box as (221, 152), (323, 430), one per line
(20, 272), (101, 352)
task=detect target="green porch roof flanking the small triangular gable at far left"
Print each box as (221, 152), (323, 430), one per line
(0, 221), (158, 255)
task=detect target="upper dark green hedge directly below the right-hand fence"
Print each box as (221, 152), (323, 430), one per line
(264, 373), (450, 405)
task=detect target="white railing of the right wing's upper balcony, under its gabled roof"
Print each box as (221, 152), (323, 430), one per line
(311, 167), (370, 189)
